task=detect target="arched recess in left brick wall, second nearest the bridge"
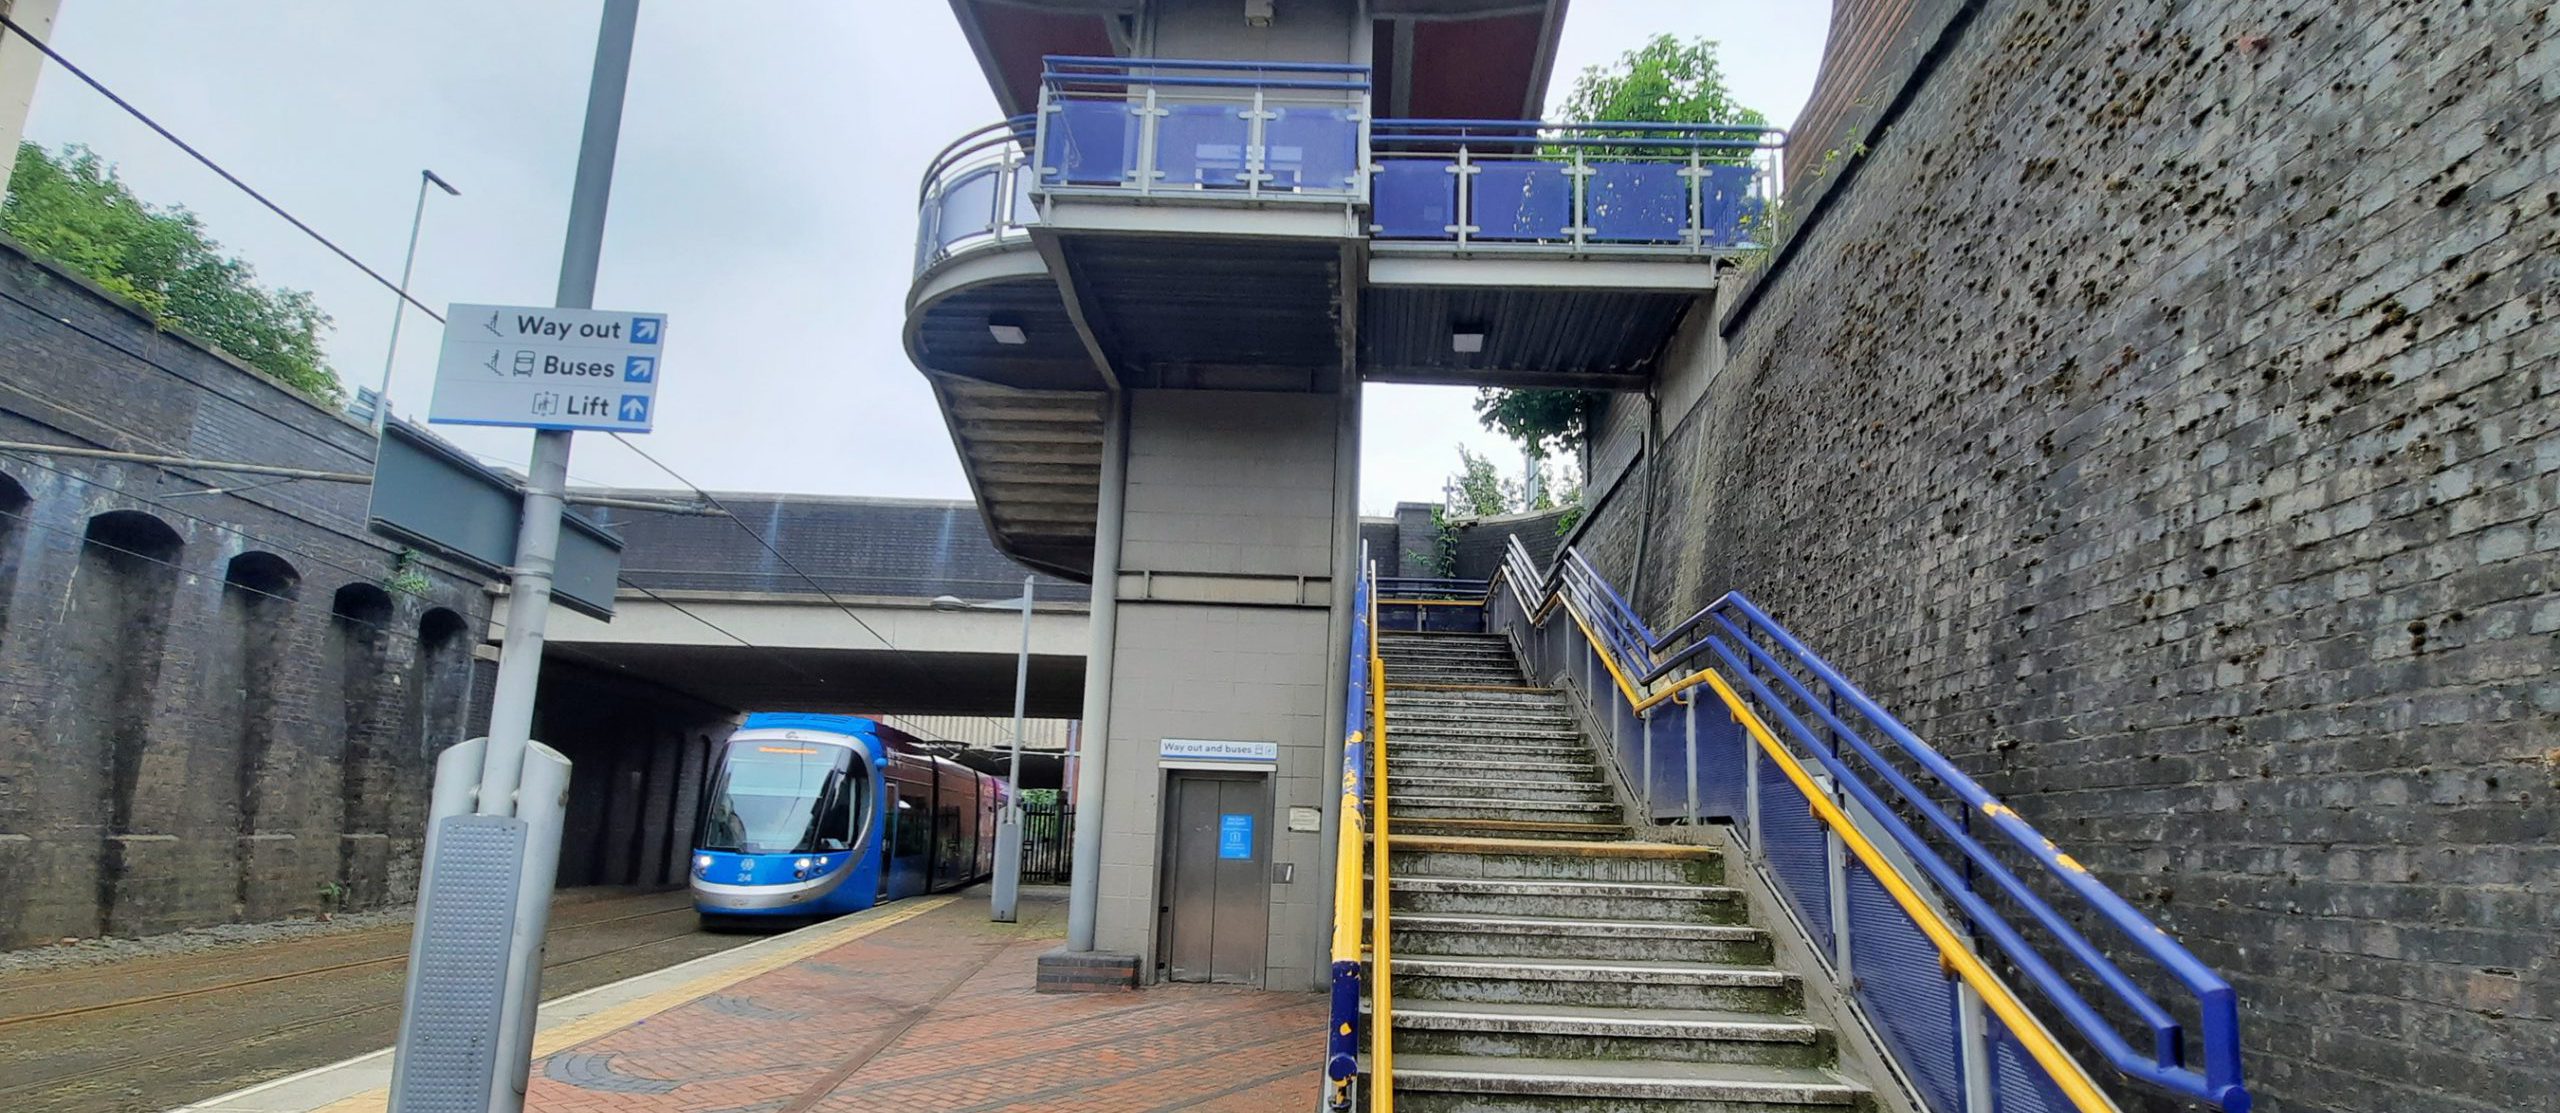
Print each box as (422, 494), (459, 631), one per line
(330, 583), (404, 908)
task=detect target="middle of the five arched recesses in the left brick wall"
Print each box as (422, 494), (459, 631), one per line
(212, 550), (302, 916)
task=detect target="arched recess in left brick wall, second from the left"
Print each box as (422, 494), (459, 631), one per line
(64, 509), (184, 839)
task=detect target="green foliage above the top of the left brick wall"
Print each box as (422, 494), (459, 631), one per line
(0, 143), (343, 404)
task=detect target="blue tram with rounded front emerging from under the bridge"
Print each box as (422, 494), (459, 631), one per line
(694, 711), (1004, 924)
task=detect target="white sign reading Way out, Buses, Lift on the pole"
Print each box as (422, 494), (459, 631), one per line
(428, 304), (666, 432)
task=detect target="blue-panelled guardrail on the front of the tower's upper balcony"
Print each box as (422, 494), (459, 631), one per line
(1032, 56), (1370, 205)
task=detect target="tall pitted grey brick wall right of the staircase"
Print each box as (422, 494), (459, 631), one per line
(1592, 0), (2560, 1113)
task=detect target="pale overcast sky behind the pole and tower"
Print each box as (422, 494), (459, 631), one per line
(28, 0), (1830, 512)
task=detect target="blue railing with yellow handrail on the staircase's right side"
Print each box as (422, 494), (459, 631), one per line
(1485, 542), (2250, 1113)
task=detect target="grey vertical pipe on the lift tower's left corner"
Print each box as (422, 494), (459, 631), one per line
(1068, 391), (1129, 952)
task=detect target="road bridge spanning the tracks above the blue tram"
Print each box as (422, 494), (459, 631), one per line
(509, 491), (1088, 719)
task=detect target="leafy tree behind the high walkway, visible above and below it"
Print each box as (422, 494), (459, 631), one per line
(1475, 33), (1769, 458)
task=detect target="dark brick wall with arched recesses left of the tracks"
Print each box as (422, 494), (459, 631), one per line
(0, 246), (489, 947)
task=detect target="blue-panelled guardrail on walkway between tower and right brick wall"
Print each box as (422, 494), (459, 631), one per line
(1370, 120), (1787, 256)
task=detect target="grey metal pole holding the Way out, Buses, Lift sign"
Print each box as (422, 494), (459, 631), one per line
(479, 0), (640, 816)
